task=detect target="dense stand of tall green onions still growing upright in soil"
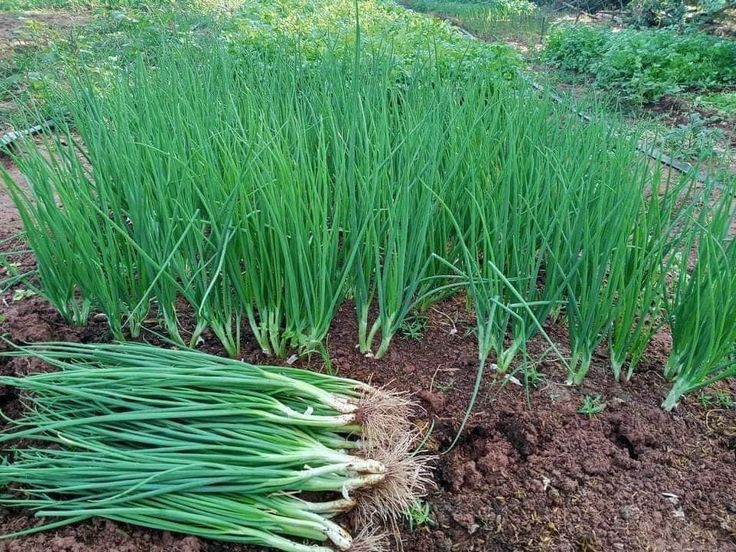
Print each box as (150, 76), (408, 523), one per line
(6, 37), (736, 406)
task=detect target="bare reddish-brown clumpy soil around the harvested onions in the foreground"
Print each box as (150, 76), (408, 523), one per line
(0, 170), (736, 552)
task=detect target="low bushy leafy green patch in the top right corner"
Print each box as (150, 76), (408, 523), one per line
(544, 26), (736, 102)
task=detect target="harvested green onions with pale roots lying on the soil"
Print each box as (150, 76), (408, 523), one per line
(0, 343), (426, 552)
